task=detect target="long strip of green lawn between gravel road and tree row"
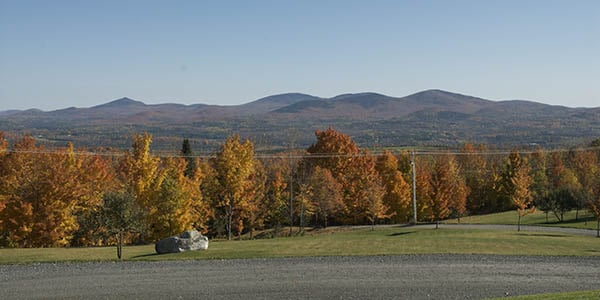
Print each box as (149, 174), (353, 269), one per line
(0, 227), (600, 264)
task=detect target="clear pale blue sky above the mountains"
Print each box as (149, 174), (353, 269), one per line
(0, 0), (600, 110)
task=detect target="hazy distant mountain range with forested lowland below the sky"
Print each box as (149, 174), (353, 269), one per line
(0, 90), (600, 152)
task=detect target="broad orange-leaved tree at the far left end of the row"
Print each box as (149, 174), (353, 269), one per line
(0, 136), (110, 247)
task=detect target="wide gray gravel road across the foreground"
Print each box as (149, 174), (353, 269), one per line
(0, 255), (600, 299)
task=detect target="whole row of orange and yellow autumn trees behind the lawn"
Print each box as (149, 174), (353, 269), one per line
(0, 128), (600, 247)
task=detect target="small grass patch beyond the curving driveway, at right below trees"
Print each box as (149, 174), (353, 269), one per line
(445, 210), (596, 229)
